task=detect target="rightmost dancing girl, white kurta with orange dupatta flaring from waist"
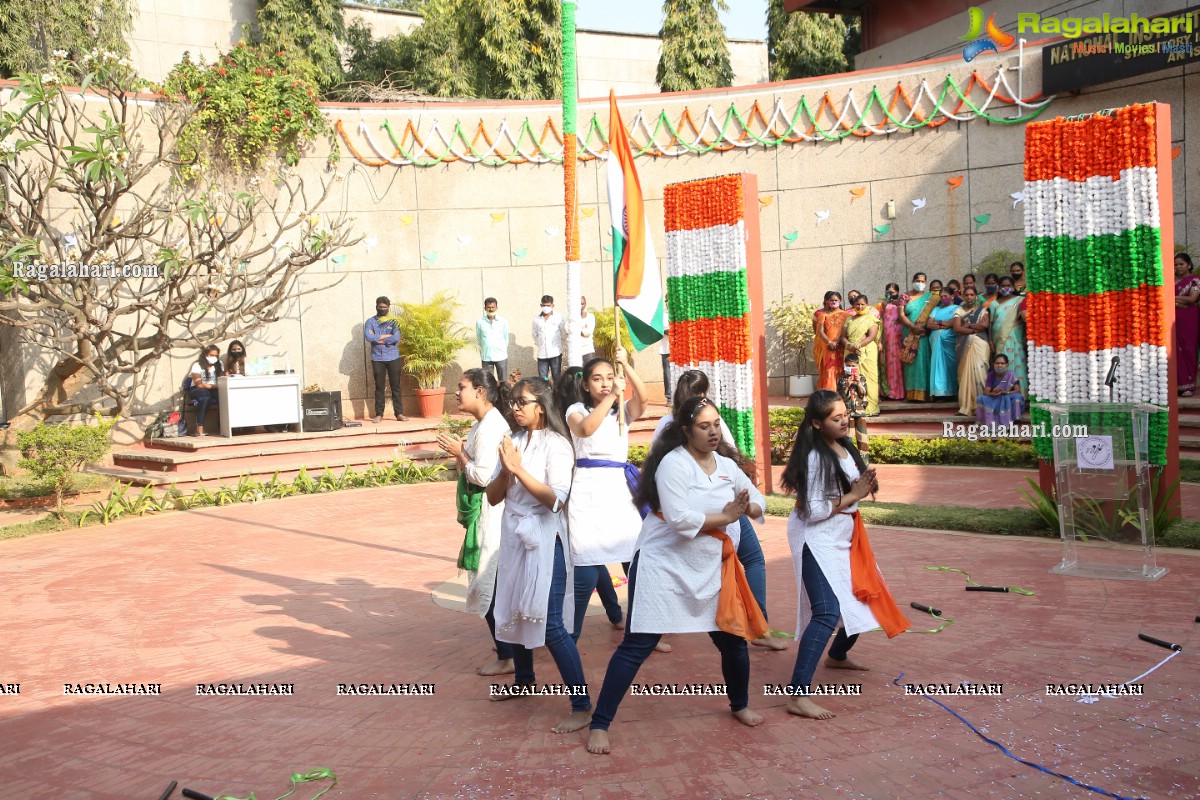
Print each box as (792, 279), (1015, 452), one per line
(782, 391), (908, 720)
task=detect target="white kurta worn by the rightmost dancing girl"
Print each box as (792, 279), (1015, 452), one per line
(787, 452), (880, 639)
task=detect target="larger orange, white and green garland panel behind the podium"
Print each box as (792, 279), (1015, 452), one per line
(1025, 104), (1169, 465)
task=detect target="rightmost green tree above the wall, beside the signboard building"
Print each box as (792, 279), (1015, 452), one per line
(767, 0), (862, 80)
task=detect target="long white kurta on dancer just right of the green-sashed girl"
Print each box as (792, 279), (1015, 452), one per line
(494, 431), (575, 648)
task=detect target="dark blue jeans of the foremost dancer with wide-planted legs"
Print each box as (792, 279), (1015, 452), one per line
(590, 554), (750, 730)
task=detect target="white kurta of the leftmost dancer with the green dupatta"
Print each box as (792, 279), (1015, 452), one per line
(463, 408), (509, 616)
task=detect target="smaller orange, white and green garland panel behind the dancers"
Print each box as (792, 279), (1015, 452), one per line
(662, 175), (755, 457)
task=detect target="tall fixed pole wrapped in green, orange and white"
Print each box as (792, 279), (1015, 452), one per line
(563, 0), (583, 367)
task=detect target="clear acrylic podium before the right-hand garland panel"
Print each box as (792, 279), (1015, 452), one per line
(1042, 403), (1166, 581)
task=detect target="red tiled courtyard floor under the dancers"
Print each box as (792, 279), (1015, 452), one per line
(0, 483), (1200, 800)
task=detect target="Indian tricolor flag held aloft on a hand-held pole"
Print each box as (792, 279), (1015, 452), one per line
(608, 91), (666, 350)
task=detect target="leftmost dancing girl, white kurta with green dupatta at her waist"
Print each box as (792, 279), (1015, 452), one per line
(438, 367), (512, 675)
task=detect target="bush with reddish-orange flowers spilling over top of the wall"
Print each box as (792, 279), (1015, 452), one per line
(163, 42), (330, 179)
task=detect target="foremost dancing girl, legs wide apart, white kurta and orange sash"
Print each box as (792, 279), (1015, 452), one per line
(587, 397), (764, 753)
